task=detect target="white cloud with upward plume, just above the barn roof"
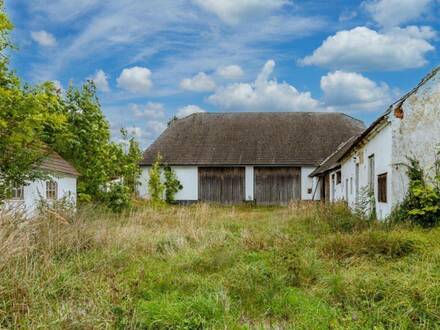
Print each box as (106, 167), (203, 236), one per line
(208, 60), (320, 111)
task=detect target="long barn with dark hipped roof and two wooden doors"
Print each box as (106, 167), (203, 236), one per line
(139, 112), (365, 205)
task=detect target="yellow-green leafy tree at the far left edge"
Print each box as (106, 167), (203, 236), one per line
(0, 1), (65, 202)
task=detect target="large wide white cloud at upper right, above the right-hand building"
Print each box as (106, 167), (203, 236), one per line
(300, 27), (434, 71)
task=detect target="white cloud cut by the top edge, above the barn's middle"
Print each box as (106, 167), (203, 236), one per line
(193, 0), (288, 25)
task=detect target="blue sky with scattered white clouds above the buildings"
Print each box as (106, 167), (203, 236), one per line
(5, 0), (440, 147)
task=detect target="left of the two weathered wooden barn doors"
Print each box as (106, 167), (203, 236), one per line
(199, 167), (245, 204)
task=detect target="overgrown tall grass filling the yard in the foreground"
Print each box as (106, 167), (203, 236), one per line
(0, 203), (440, 329)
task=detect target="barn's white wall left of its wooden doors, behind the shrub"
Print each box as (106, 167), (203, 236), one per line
(138, 166), (199, 201)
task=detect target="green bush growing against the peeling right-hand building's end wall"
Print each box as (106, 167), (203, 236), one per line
(390, 158), (440, 227)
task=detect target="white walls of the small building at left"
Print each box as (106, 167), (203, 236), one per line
(4, 175), (77, 216)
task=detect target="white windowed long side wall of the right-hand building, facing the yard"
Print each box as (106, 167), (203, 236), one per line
(338, 124), (393, 219)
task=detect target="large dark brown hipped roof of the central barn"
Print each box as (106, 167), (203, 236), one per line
(141, 112), (365, 166)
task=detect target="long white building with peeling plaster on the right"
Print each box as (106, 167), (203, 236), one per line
(311, 68), (440, 219)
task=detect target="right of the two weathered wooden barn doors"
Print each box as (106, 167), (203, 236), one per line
(254, 167), (301, 205)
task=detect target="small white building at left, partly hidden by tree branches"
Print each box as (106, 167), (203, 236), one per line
(2, 152), (79, 217)
